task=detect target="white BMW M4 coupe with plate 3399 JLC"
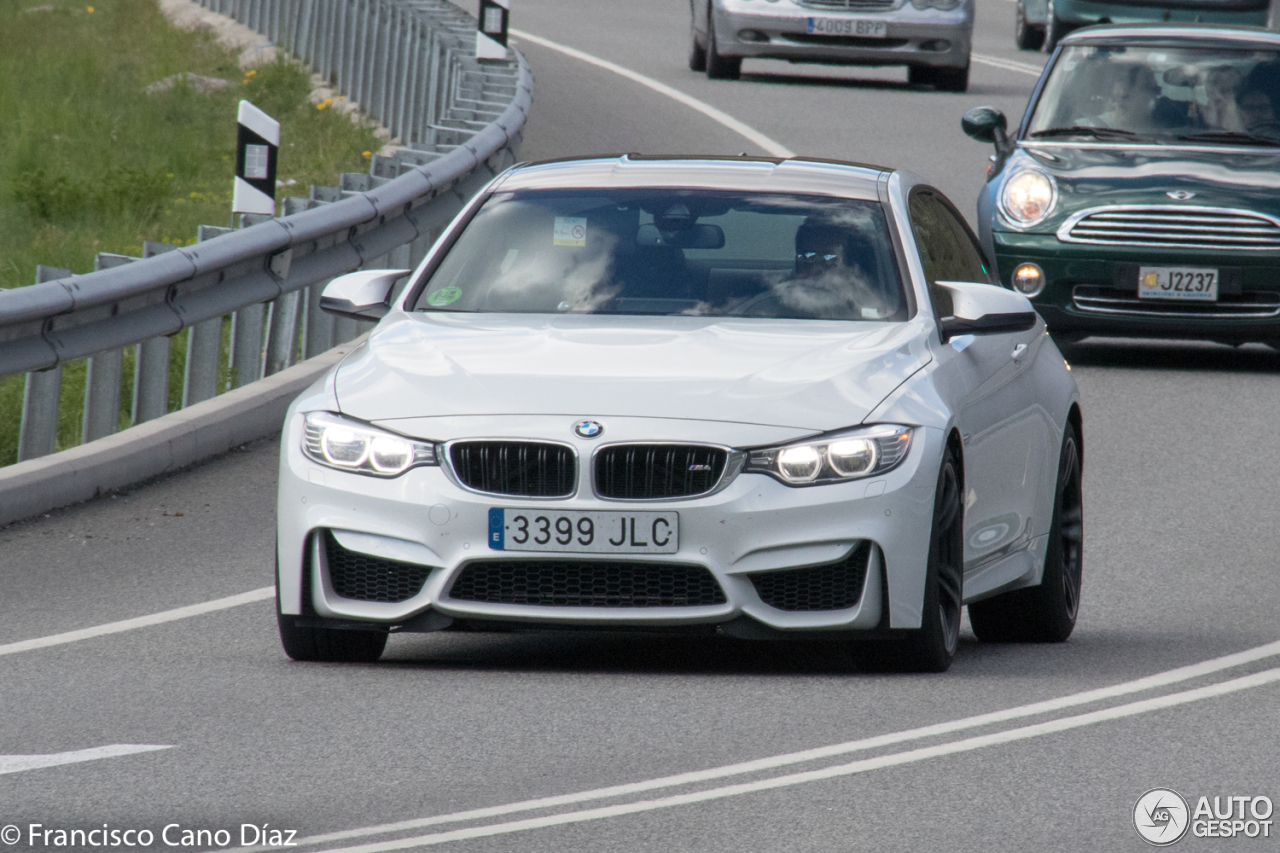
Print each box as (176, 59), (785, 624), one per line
(276, 155), (1083, 671)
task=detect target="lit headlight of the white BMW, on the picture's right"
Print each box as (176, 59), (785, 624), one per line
(744, 424), (911, 485)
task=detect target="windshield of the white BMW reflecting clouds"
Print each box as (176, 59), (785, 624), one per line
(415, 190), (906, 320)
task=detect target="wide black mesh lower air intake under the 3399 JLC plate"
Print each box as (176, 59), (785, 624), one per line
(449, 560), (726, 607)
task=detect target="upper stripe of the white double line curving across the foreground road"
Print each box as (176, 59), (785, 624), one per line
(241, 642), (1280, 853)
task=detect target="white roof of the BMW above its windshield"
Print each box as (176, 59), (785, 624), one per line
(493, 154), (892, 201)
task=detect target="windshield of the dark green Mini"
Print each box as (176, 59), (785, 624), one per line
(1024, 45), (1280, 145)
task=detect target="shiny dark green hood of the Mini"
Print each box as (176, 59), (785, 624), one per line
(1004, 145), (1280, 222)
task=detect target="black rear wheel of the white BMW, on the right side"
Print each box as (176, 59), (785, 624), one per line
(969, 424), (1084, 643)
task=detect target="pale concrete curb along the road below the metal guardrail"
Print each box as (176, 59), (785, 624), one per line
(0, 336), (365, 525)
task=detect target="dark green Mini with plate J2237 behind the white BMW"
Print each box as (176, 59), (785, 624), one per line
(963, 26), (1280, 348)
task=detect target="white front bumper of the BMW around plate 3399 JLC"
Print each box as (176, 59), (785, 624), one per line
(278, 414), (942, 631)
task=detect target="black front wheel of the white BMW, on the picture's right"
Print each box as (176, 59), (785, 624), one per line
(854, 447), (964, 672)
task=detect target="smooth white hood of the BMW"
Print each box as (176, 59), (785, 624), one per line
(335, 313), (929, 430)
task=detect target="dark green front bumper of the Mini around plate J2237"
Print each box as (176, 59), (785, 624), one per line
(993, 231), (1280, 343)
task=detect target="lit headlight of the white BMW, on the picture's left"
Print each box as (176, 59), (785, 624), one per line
(302, 411), (439, 476)
